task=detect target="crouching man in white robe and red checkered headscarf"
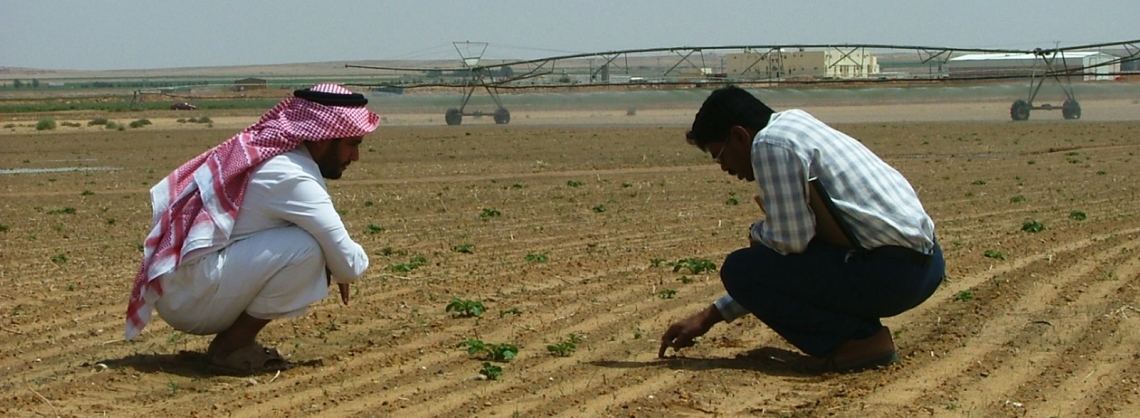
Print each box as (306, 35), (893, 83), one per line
(127, 84), (380, 375)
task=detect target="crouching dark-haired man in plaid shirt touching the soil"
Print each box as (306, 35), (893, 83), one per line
(659, 87), (945, 372)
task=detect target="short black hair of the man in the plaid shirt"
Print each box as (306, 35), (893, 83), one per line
(685, 85), (775, 150)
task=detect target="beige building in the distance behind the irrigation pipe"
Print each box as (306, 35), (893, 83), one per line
(725, 48), (879, 79)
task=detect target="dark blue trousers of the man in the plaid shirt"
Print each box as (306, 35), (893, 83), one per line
(720, 239), (946, 356)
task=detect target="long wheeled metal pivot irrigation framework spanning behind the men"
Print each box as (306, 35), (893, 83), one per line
(345, 40), (1140, 125)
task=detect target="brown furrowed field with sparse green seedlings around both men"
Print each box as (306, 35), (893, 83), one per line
(0, 95), (1140, 417)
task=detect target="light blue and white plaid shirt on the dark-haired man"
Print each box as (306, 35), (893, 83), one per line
(716, 109), (934, 321)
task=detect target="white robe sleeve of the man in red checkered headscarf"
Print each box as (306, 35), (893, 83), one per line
(268, 175), (368, 282)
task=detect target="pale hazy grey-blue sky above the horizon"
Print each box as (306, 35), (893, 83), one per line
(0, 0), (1140, 69)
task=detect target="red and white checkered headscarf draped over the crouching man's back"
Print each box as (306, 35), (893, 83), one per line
(127, 84), (380, 339)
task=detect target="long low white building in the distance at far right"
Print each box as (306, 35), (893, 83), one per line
(947, 51), (1121, 81)
